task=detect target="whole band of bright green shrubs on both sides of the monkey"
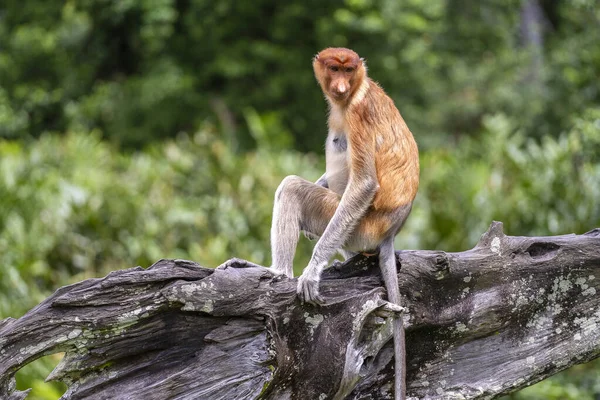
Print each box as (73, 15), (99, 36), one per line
(0, 109), (600, 399)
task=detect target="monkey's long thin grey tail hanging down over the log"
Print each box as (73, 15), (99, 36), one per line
(379, 236), (406, 400)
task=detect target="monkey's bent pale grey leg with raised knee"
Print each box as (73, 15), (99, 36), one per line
(271, 175), (339, 277)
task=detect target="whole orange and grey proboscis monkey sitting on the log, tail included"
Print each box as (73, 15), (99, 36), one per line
(271, 48), (419, 399)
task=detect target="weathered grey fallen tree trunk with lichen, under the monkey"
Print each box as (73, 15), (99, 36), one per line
(0, 223), (600, 400)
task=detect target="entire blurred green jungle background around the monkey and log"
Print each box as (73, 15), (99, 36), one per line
(0, 0), (600, 400)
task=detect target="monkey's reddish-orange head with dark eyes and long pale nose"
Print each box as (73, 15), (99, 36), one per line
(313, 47), (366, 105)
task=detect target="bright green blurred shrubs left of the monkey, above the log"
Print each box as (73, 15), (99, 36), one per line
(0, 128), (319, 317)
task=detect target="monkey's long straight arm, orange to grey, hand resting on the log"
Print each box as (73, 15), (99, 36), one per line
(297, 129), (378, 303)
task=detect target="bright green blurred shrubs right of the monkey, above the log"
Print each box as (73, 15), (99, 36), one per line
(407, 109), (600, 251)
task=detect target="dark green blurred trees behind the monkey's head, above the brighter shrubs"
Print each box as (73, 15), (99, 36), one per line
(0, 0), (600, 151)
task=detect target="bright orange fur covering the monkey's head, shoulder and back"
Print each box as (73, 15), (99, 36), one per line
(313, 48), (419, 216)
